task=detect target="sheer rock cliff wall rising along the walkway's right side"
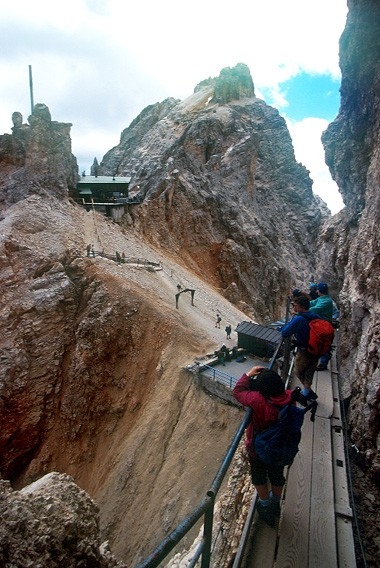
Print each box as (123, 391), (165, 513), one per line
(320, 0), (380, 481)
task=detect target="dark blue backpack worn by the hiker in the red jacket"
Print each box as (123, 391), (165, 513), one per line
(253, 394), (317, 466)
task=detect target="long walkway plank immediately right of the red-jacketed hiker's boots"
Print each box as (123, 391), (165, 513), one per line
(274, 415), (315, 568)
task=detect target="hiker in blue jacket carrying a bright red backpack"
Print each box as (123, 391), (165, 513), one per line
(281, 296), (334, 400)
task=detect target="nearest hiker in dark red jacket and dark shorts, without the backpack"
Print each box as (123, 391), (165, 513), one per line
(233, 366), (292, 527)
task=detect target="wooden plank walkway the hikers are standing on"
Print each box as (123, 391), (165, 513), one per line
(233, 350), (356, 568)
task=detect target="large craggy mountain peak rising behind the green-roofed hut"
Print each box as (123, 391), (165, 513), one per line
(100, 64), (327, 321)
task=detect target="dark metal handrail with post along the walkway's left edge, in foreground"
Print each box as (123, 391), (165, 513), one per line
(137, 340), (283, 568)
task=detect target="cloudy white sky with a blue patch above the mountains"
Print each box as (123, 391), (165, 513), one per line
(0, 0), (347, 213)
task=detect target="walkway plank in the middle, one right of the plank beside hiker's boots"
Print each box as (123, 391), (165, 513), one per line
(309, 417), (337, 568)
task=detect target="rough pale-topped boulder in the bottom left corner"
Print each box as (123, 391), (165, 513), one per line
(0, 473), (126, 568)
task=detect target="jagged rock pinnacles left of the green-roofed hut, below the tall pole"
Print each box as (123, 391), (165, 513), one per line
(0, 104), (78, 212)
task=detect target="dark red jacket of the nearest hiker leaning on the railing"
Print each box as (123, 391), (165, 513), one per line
(233, 373), (292, 457)
